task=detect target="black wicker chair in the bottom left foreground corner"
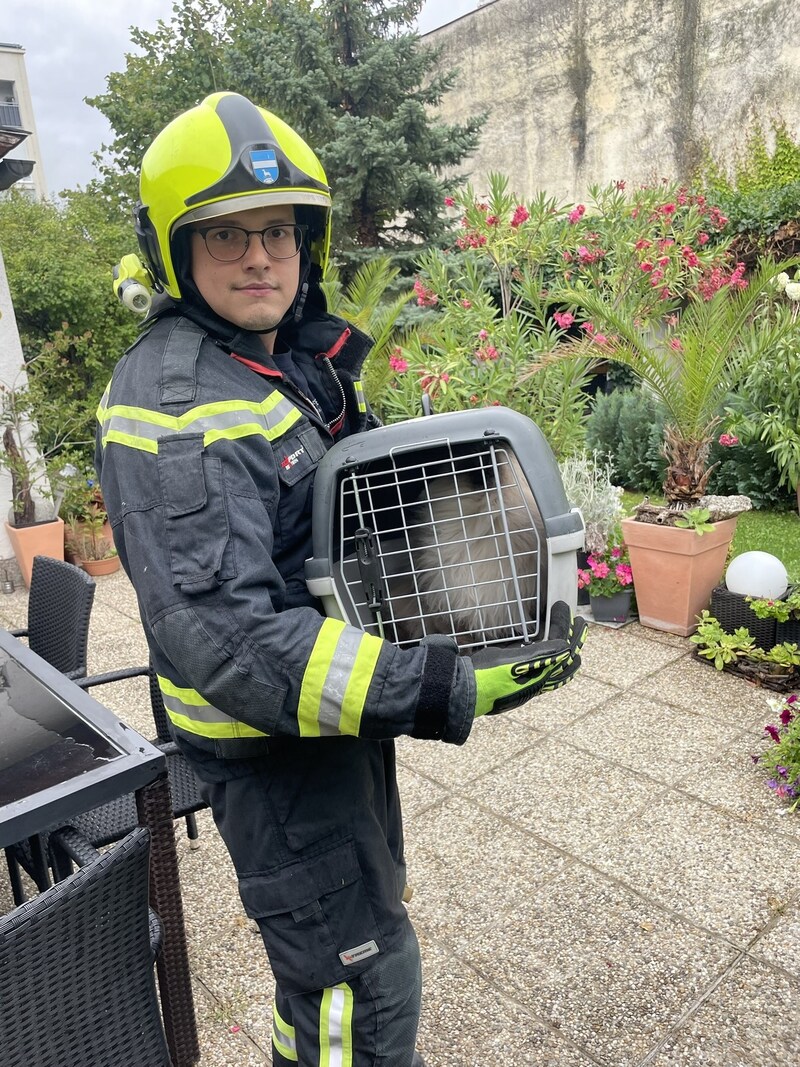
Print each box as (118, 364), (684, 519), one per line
(0, 828), (171, 1067)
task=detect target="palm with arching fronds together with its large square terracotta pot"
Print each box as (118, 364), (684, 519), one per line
(563, 259), (797, 636)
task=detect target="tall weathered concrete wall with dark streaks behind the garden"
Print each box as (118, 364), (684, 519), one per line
(423, 0), (800, 201)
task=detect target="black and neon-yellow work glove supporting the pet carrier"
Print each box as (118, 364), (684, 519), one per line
(470, 601), (588, 718)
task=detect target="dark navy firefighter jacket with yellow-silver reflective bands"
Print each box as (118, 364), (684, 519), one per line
(96, 307), (475, 760)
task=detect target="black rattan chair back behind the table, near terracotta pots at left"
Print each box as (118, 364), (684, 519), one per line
(10, 556), (95, 679)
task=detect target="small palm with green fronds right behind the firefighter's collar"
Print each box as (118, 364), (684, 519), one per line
(322, 255), (414, 411)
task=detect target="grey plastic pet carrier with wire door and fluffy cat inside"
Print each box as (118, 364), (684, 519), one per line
(305, 408), (583, 652)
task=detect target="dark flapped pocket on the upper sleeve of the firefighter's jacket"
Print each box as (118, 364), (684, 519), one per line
(158, 433), (236, 593)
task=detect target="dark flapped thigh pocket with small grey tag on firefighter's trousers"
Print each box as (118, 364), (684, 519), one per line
(239, 841), (385, 996)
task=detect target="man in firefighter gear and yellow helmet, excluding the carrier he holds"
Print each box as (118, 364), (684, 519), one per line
(96, 93), (585, 1067)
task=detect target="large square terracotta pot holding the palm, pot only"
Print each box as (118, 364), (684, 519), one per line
(622, 516), (736, 637)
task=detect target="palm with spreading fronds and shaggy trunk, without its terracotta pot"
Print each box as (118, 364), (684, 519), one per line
(558, 262), (798, 508)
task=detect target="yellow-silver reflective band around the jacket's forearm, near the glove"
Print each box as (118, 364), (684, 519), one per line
(298, 619), (383, 737)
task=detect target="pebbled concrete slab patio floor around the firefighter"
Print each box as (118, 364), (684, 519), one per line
(0, 572), (800, 1067)
